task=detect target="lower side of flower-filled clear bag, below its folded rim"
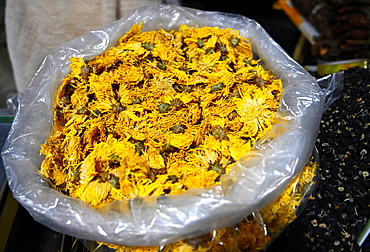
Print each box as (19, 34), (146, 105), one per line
(79, 147), (320, 252)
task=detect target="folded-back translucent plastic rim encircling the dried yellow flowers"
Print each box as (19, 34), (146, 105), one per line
(2, 5), (324, 246)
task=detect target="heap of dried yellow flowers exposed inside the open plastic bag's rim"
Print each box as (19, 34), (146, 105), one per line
(40, 24), (292, 250)
